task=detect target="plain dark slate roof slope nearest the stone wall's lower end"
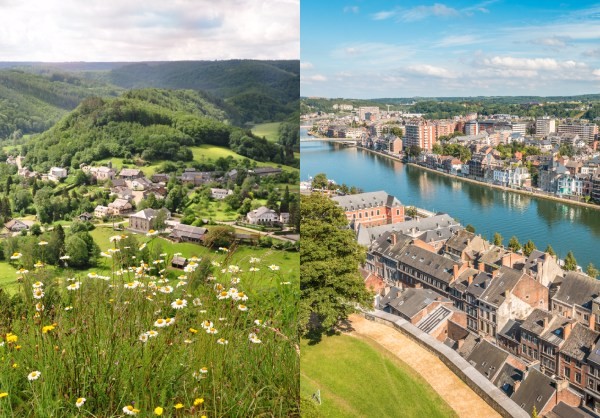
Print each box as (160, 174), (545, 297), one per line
(511, 369), (556, 414)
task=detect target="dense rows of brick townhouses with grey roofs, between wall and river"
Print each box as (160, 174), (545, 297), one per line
(338, 195), (600, 414)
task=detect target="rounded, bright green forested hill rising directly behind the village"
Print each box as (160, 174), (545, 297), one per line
(21, 89), (294, 171)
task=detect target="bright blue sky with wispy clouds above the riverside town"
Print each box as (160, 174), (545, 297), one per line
(300, 0), (600, 98)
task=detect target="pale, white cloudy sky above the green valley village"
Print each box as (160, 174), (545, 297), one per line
(0, 0), (300, 62)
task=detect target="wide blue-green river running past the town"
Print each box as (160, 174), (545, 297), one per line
(300, 129), (600, 270)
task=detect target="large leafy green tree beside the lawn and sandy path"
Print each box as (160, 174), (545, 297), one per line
(298, 194), (372, 335)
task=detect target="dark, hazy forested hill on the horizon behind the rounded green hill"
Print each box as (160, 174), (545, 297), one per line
(105, 60), (300, 124)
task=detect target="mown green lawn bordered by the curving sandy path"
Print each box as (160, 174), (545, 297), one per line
(300, 335), (456, 418)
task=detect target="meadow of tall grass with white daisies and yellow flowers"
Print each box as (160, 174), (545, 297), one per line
(0, 235), (299, 417)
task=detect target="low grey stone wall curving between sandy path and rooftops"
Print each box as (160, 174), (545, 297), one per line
(362, 311), (529, 418)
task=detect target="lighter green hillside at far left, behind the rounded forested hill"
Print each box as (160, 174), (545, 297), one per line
(0, 70), (121, 139)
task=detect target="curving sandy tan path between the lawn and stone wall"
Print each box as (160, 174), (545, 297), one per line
(349, 315), (500, 418)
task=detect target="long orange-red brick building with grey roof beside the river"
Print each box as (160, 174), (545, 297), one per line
(332, 191), (404, 229)
